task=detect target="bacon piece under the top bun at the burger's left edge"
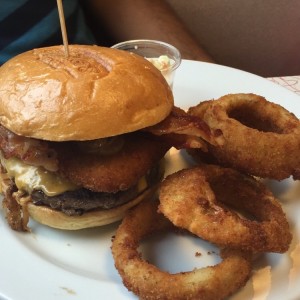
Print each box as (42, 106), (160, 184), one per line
(0, 125), (58, 172)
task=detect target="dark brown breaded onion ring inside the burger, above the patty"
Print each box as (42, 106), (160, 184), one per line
(55, 133), (169, 193)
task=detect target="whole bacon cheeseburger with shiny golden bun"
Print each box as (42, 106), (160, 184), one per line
(0, 45), (174, 231)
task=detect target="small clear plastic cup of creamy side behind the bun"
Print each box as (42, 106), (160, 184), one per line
(112, 40), (181, 88)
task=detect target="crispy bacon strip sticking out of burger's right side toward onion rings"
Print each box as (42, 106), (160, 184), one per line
(145, 106), (224, 149)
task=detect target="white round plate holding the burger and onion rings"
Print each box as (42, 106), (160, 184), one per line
(0, 61), (300, 300)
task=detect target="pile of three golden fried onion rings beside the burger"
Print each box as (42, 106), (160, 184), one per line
(112, 94), (294, 300)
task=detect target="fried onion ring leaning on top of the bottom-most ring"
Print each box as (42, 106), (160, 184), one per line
(159, 165), (292, 253)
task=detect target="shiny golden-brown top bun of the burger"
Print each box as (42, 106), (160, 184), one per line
(0, 45), (174, 141)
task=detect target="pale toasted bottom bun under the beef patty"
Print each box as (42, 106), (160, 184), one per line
(27, 187), (157, 230)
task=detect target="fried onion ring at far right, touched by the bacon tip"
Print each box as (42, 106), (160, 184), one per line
(189, 94), (300, 180)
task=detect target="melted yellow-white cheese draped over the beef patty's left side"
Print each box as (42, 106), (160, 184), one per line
(1, 157), (78, 196)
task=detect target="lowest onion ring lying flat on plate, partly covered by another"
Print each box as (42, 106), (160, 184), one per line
(112, 201), (251, 300)
